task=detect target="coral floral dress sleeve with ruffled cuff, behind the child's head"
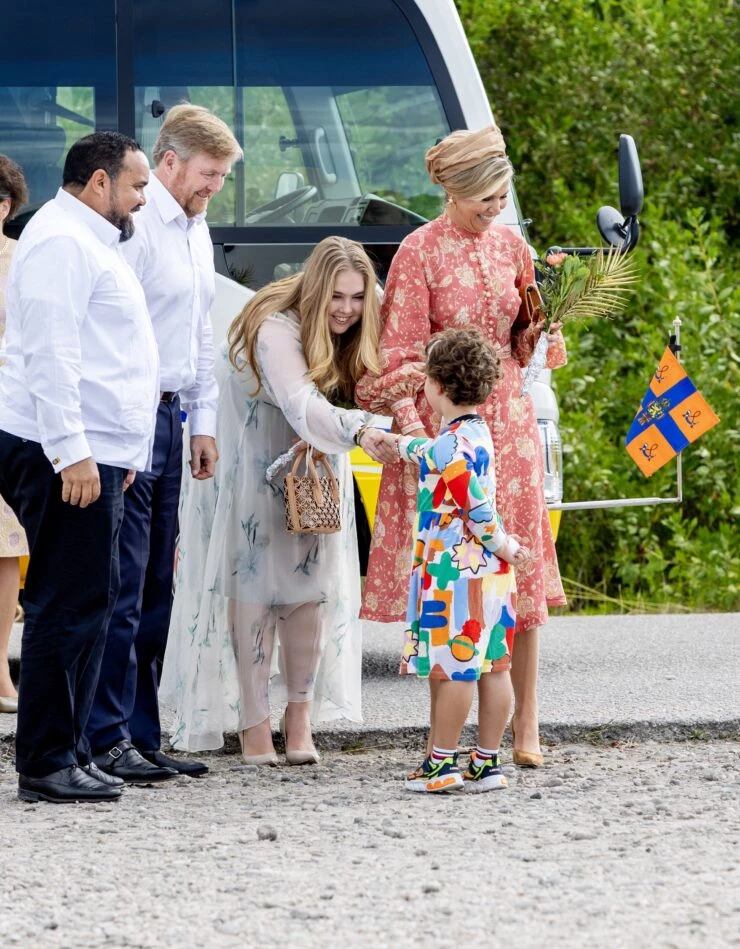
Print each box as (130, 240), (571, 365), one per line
(355, 237), (431, 434)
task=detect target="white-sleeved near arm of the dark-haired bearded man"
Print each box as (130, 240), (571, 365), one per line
(17, 237), (94, 472)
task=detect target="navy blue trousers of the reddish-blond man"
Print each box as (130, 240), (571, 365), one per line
(87, 399), (182, 755)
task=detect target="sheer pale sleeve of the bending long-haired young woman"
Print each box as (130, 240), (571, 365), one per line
(257, 315), (368, 454)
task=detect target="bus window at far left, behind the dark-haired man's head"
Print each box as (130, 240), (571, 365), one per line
(0, 0), (117, 221)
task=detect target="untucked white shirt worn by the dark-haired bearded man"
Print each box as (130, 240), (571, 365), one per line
(0, 189), (159, 471)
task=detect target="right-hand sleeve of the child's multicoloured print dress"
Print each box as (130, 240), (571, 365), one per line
(430, 432), (510, 553)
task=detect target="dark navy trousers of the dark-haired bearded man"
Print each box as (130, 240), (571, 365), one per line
(0, 432), (126, 778)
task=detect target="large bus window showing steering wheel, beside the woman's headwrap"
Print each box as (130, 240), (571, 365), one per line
(233, 0), (450, 226)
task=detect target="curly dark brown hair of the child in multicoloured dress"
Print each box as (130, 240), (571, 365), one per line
(425, 329), (501, 405)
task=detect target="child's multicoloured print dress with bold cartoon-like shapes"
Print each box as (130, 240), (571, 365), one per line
(399, 415), (516, 682)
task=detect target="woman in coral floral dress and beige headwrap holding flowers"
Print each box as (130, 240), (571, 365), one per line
(356, 126), (566, 766)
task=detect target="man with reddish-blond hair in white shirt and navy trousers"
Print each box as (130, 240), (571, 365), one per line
(88, 104), (242, 781)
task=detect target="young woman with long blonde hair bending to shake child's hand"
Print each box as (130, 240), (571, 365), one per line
(160, 237), (394, 764)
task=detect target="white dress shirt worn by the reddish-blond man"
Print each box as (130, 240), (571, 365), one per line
(123, 174), (218, 437)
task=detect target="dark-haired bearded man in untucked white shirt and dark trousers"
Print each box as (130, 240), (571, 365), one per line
(0, 132), (159, 801)
